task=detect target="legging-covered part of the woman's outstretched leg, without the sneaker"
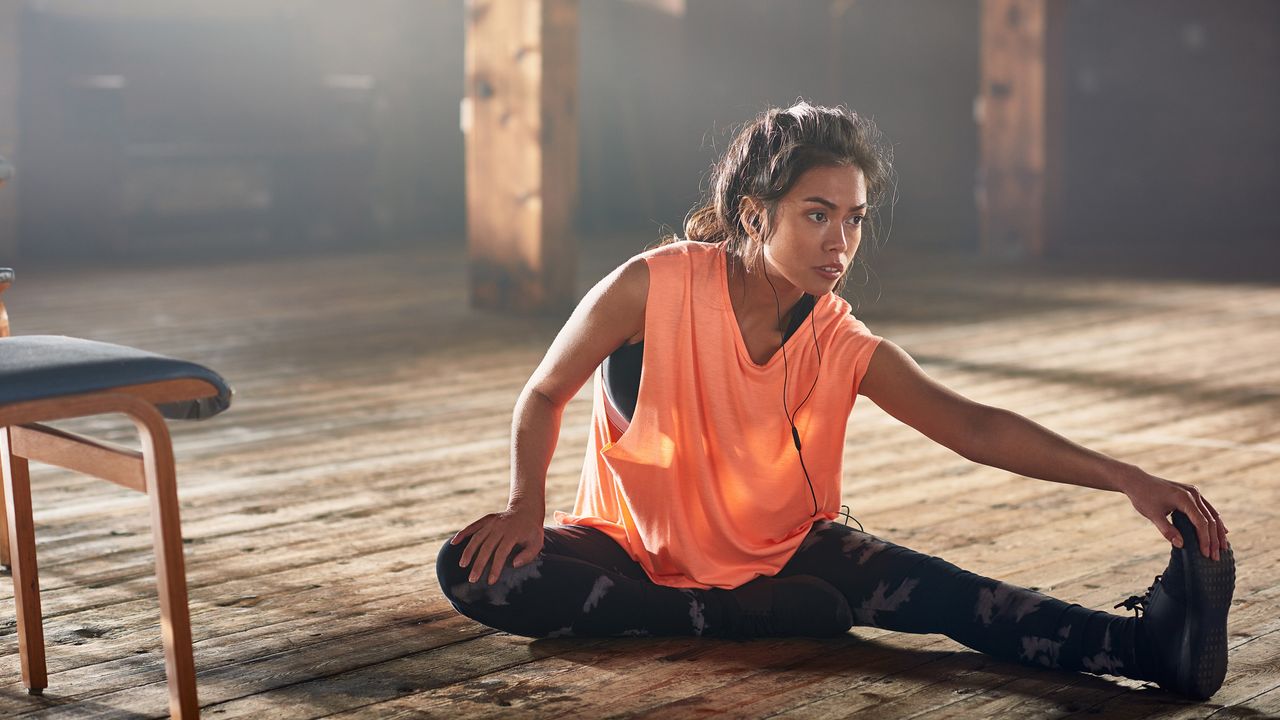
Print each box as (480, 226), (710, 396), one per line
(780, 521), (1149, 679)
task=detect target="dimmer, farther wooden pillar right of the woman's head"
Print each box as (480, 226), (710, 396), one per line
(975, 0), (1066, 256)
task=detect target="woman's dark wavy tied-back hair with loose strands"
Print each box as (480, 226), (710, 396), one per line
(663, 100), (895, 292)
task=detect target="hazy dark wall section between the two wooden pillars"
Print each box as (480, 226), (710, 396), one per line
(580, 0), (978, 253)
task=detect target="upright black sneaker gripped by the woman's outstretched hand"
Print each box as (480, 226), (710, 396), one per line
(1116, 511), (1235, 700)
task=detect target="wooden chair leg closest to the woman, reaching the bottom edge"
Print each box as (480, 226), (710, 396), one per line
(134, 414), (200, 717)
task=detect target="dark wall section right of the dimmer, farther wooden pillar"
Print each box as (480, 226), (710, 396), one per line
(1055, 0), (1280, 265)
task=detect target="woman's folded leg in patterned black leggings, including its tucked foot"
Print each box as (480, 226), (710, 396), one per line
(436, 525), (852, 637)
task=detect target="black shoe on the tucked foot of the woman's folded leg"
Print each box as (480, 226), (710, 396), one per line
(712, 575), (854, 639)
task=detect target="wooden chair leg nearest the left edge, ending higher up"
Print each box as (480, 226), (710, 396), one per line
(0, 428), (49, 694)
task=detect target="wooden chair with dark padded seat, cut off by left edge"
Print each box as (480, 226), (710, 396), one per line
(0, 268), (232, 717)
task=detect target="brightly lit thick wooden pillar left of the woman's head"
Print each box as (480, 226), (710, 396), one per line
(462, 0), (577, 313)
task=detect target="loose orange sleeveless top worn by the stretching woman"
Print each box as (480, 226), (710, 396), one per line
(554, 241), (881, 588)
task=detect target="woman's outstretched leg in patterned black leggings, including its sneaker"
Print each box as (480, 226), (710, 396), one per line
(778, 511), (1235, 700)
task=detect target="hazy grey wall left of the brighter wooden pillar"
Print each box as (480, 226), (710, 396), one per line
(14, 0), (463, 260)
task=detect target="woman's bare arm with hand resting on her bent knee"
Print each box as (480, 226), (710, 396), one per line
(449, 256), (649, 584)
